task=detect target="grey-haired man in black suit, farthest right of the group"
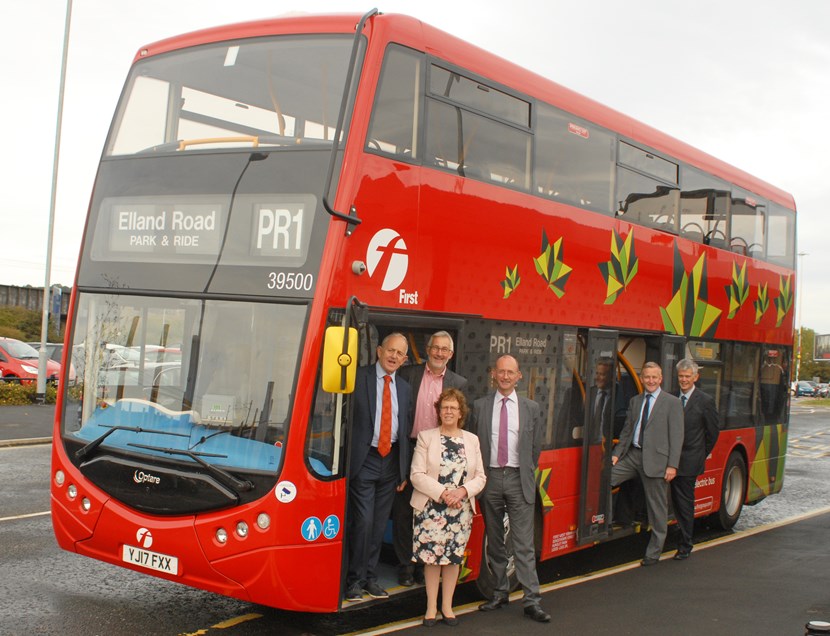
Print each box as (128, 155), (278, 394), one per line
(671, 358), (720, 561)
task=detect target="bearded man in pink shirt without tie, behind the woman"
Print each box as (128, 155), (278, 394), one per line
(392, 331), (467, 587)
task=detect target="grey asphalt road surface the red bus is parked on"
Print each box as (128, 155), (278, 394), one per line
(0, 400), (830, 636)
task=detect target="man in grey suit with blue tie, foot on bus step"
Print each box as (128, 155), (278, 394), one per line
(611, 362), (683, 566)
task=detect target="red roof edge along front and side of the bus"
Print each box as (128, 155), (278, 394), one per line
(134, 13), (795, 210)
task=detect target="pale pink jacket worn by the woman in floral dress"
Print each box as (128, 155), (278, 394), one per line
(409, 427), (487, 512)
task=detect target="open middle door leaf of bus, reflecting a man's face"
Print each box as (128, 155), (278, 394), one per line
(577, 329), (617, 545)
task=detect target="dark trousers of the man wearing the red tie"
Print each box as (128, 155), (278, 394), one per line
(346, 444), (399, 587)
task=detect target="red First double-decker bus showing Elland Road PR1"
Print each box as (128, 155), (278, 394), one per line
(52, 11), (795, 612)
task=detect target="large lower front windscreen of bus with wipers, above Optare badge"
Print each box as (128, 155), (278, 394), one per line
(63, 293), (306, 514)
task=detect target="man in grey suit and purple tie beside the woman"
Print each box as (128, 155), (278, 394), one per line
(473, 355), (550, 623)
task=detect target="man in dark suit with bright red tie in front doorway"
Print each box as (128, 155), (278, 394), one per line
(346, 333), (411, 601)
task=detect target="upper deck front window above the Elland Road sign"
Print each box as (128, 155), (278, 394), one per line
(106, 36), (351, 155)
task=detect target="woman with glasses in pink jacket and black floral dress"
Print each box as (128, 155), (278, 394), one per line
(410, 389), (485, 626)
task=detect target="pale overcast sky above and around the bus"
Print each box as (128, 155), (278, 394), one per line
(0, 0), (830, 333)
